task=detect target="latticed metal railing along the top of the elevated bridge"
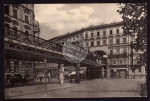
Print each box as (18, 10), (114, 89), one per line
(5, 27), (96, 64)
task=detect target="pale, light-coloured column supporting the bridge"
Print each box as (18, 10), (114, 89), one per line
(58, 64), (64, 84)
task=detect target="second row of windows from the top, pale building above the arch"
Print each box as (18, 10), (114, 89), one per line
(87, 38), (126, 47)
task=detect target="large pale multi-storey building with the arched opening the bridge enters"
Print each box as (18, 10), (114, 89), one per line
(47, 22), (145, 78)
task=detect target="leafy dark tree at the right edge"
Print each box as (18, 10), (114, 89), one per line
(117, 3), (147, 69)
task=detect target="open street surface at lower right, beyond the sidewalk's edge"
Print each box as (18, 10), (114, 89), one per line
(8, 79), (145, 98)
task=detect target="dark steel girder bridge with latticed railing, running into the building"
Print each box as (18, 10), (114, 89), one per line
(4, 28), (106, 82)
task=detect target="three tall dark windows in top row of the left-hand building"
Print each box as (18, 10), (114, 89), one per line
(5, 5), (29, 23)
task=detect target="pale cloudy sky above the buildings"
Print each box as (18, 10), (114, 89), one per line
(34, 3), (122, 40)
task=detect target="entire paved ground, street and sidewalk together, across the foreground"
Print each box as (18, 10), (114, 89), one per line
(5, 79), (146, 98)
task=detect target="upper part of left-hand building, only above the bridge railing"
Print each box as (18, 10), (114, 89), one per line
(4, 4), (40, 36)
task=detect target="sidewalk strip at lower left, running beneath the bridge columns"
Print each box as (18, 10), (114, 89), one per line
(5, 79), (77, 98)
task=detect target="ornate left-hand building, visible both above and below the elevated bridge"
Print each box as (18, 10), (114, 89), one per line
(4, 4), (40, 75)
